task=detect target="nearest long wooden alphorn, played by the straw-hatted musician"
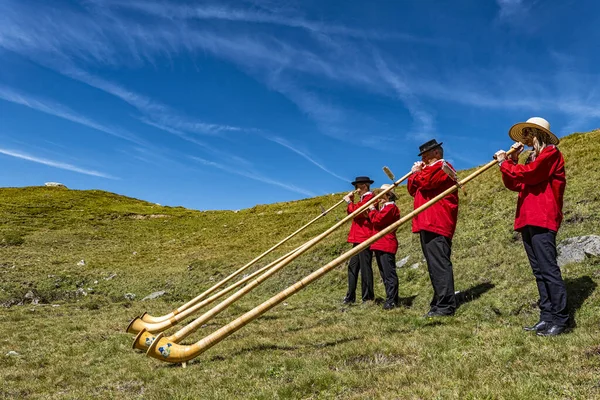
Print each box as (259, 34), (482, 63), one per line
(146, 148), (515, 363)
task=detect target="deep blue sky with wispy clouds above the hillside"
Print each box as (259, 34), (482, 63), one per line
(0, 0), (600, 209)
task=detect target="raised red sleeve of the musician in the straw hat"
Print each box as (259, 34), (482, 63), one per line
(500, 146), (560, 189)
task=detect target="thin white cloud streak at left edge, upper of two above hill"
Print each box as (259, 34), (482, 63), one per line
(0, 85), (143, 144)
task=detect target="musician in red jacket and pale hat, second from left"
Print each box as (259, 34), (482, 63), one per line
(369, 184), (400, 310)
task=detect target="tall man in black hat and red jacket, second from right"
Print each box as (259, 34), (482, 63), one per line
(407, 139), (458, 317)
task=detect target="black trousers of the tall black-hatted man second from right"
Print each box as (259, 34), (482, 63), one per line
(419, 231), (456, 314)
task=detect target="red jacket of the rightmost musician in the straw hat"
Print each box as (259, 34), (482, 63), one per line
(500, 145), (567, 232)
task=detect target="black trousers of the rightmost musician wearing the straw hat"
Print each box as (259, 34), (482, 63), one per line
(521, 225), (569, 326)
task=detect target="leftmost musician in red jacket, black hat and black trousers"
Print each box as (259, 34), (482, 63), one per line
(344, 176), (375, 304)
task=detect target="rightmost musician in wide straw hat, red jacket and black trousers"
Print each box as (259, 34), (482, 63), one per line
(495, 117), (569, 336)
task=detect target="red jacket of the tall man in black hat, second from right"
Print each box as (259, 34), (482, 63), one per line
(406, 160), (458, 239)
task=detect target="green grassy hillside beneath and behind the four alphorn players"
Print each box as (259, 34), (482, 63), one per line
(0, 131), (600, 399)
